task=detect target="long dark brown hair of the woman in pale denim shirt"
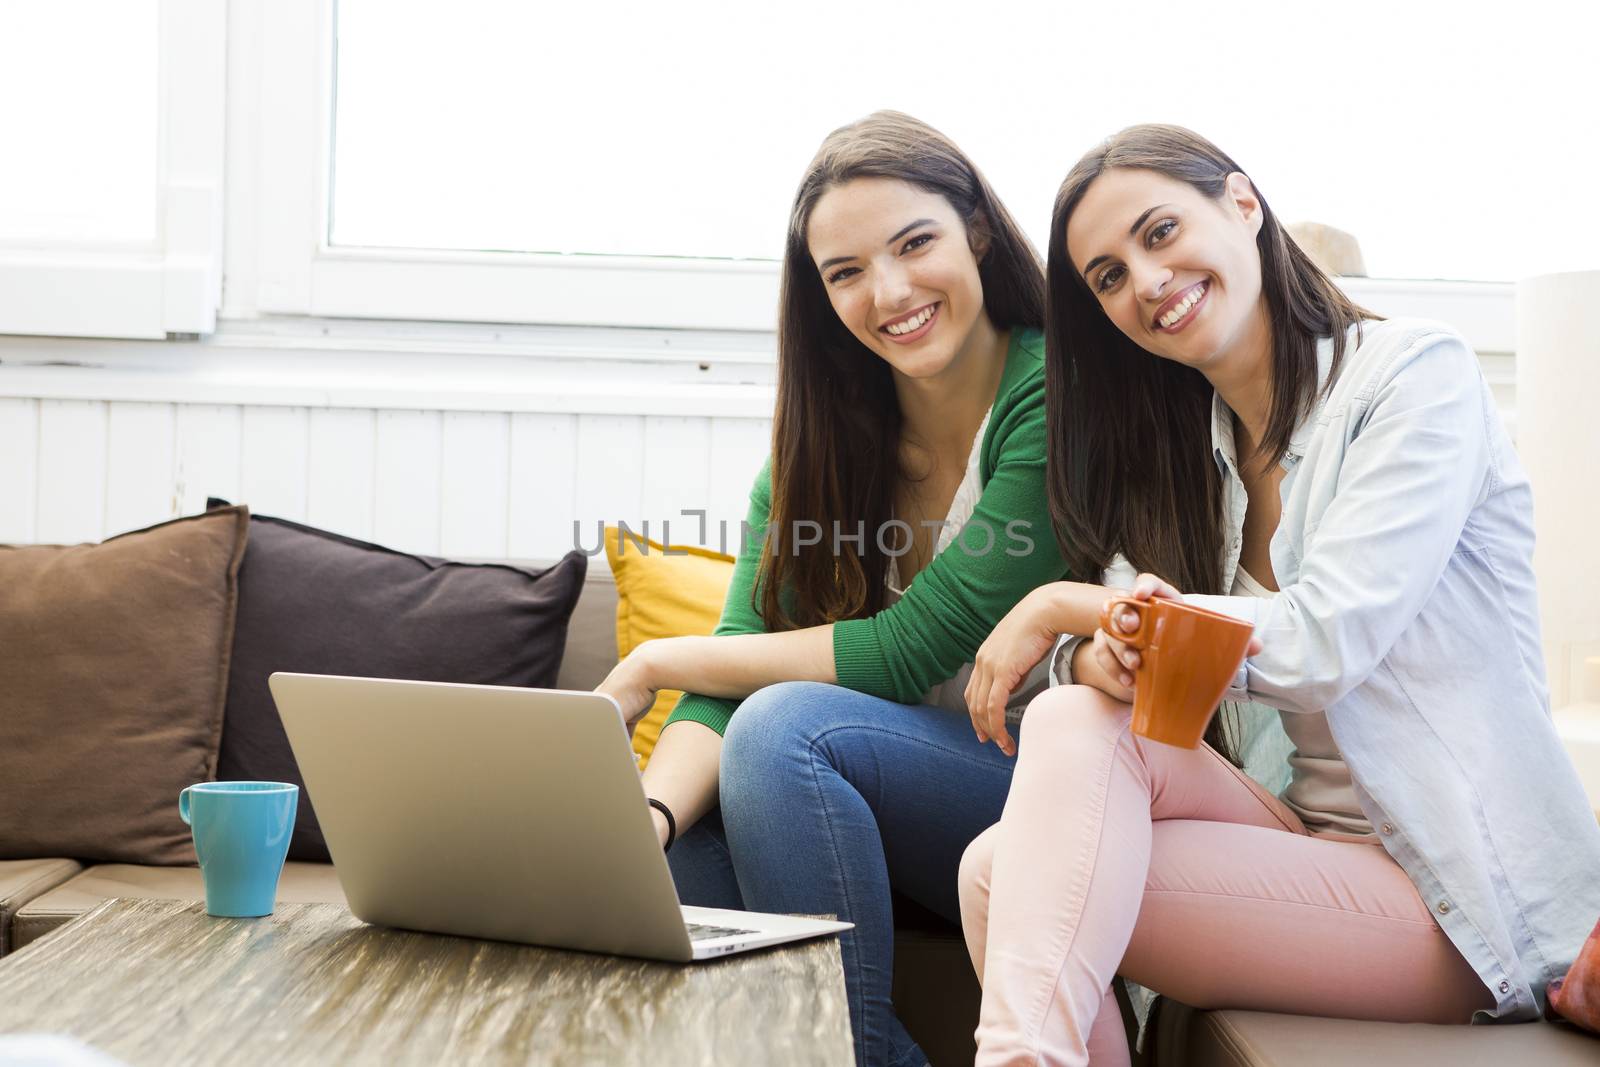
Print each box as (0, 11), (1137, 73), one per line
(1045, 125), (1378, 758)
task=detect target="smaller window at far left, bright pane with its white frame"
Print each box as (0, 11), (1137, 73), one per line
(0, 0), (226, 338)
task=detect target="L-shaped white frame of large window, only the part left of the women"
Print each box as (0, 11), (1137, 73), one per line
(254, 0), (779, 330)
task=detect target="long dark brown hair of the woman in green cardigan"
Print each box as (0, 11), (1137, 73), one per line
(752, 110), (1045, 630)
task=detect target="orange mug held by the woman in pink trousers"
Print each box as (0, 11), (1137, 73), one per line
(1101, 597), (1254, 749)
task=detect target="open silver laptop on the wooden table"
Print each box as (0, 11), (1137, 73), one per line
(269, 673), (851, 961)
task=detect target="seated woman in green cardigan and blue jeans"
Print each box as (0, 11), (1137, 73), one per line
(600, 112), (1066, 1067)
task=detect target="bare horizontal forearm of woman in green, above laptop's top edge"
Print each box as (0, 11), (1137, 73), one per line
(635, 625), (838, 699)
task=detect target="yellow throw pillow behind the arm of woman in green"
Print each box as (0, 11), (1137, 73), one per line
(605, 526), (733, 766)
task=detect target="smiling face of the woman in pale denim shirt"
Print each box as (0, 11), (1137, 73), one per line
(1067, 168), (1272, 378)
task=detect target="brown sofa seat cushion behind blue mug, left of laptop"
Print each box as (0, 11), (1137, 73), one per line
(13, 861), (346, 949)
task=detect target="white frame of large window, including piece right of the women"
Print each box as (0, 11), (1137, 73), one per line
(246, 0), (1515, 352)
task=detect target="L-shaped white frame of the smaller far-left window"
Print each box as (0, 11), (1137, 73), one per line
(0, 0), (227, 339)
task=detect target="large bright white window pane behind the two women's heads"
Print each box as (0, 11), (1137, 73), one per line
(331, 0), (1600, 280)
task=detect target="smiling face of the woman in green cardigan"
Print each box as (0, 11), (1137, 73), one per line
(806, 178), (997, 379)
